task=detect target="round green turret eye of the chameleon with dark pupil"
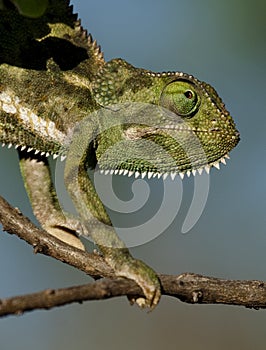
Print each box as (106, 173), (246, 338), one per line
(160, 81), (200, 117)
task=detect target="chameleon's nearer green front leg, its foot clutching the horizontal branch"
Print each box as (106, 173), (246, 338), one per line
(64, 123), (161, 308)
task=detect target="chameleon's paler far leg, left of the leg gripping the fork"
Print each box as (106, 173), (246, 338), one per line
(19, 152), (85, 250)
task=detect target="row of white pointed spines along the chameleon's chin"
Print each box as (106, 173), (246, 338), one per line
(100, 154), (230, 180)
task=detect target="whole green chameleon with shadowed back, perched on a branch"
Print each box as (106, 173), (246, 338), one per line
(0, 0), (239, 307)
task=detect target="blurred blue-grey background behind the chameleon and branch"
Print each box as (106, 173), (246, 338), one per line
(0, 0), (266, 350)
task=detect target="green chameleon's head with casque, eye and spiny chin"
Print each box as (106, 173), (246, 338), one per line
(93, 60), (239, 177)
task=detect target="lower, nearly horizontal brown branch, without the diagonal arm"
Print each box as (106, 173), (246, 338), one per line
(0, 273), (266, 317)
